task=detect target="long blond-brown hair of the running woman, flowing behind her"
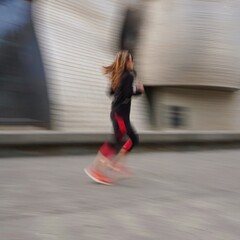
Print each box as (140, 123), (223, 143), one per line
(103, 50), (131, 91)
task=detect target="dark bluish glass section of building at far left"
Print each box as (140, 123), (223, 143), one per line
(0, 0), (50, 128)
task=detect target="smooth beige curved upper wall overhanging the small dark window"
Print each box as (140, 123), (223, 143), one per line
(137, 0), (240, 90)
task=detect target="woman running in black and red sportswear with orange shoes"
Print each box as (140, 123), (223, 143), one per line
(85, 50), (144, 184)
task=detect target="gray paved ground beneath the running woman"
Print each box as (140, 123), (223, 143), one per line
(0, 150), (240, 240)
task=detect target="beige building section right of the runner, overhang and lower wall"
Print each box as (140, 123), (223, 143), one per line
(137, 0), (240, 130)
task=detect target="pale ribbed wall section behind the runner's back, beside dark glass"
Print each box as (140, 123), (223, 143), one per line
(33, 0), (148, 131)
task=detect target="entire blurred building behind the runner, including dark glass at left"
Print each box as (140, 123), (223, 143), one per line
(0, 0), (240, 132)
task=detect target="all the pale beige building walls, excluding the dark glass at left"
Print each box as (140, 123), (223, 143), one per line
(33, 0), (240, 131)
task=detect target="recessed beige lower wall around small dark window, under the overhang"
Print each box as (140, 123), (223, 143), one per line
(155, 88), (236, 131)
